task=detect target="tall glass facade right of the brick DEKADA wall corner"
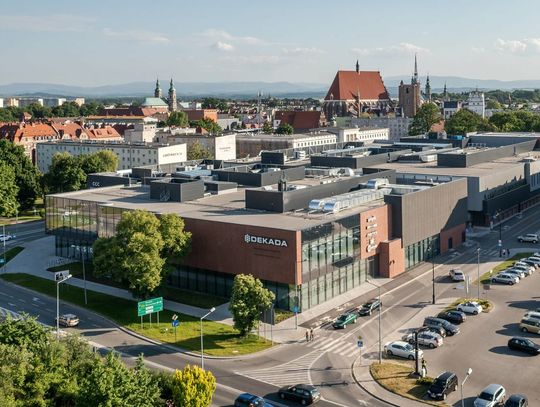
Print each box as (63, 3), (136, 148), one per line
(293, 215), (379, 309)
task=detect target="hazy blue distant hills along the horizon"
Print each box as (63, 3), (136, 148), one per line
(0, 76), (540, 98)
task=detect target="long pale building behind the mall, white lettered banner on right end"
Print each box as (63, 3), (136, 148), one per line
(36, 140), (187, 173)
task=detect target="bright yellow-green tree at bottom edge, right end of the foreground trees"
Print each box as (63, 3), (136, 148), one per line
(173, 365), (216, 407)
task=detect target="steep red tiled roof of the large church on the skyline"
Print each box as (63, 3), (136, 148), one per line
(324, 71), (390, 100)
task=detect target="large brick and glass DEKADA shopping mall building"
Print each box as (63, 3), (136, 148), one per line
(46, 155), (467, 310)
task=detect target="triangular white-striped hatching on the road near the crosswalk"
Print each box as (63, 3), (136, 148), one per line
(235, 350), (321, 387)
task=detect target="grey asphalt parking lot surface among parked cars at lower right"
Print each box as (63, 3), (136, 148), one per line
(384, 255), (540, 406)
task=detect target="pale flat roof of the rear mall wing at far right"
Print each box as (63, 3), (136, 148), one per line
(370, 151), (540, 177)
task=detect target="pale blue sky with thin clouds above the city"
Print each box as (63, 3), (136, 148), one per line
(0, 0), (540, 86)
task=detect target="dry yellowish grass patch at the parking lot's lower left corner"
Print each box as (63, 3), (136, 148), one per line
(369, 362), (447, 406)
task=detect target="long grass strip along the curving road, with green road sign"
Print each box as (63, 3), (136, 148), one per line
(1, 273), (271, 356)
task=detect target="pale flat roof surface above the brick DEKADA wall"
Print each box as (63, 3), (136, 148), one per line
(48, 183), (385, 231)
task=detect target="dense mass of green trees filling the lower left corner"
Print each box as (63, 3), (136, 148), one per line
(0, 315), (216, 407)
